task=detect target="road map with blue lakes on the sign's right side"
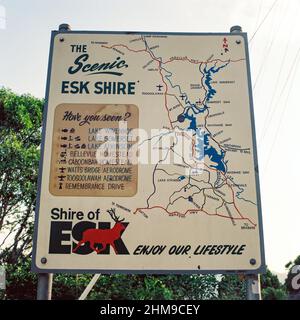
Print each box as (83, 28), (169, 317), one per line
(102, 36), (257, 228)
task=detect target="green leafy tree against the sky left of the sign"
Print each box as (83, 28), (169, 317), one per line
(0, 88), (43, 263)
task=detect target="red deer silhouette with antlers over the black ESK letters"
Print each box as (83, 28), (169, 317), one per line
(73, 209), (126, 254)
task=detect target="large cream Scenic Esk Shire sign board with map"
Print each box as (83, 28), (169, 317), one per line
(33, 27), (265, 273)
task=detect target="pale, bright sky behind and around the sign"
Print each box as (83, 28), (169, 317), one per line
(0, 0), (300, 272)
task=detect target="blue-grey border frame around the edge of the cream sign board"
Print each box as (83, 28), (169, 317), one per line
(31, 29), (266, 275)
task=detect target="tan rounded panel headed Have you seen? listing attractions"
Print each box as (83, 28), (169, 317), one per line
(50, 104), (138, 197)
